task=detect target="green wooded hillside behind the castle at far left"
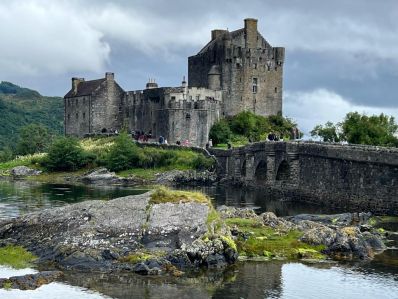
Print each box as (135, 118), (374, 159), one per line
(0, 81), (64, 150)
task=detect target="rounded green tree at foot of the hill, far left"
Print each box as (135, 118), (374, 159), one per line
(17, 124), (51, 155)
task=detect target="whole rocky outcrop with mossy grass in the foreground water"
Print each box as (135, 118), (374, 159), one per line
(0, 191), (386, 285)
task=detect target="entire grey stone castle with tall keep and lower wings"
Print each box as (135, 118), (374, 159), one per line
(64, 19), (284, 146)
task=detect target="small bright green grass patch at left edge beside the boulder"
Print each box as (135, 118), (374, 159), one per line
(0, 245), (36, 269)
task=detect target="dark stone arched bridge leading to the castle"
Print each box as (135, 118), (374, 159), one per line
(211, 142), (398, 215)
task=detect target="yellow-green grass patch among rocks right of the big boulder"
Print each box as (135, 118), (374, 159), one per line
(225, 218), (325, 259)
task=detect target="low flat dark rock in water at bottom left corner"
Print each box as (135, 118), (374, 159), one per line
(0, 271), (63, 290)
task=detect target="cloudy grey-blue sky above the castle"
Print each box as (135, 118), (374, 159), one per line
(0, 0), (398, 133)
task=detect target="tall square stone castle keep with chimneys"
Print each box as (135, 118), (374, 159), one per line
(188, 18), (285, 116)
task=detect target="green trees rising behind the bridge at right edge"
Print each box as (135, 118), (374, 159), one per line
(311, 112), (398, 147)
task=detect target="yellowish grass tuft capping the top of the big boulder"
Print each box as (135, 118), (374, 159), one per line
(149, 186), (211, 205)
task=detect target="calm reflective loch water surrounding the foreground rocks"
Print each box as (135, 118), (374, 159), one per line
(0, 180), (398, 299)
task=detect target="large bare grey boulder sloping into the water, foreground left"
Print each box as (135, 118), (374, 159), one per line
(0, 192), (236, 273)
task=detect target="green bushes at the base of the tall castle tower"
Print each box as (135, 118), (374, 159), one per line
(209, 111), (297, 146)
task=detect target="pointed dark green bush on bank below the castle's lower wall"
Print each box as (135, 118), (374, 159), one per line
(106, 132), (144, 171)
